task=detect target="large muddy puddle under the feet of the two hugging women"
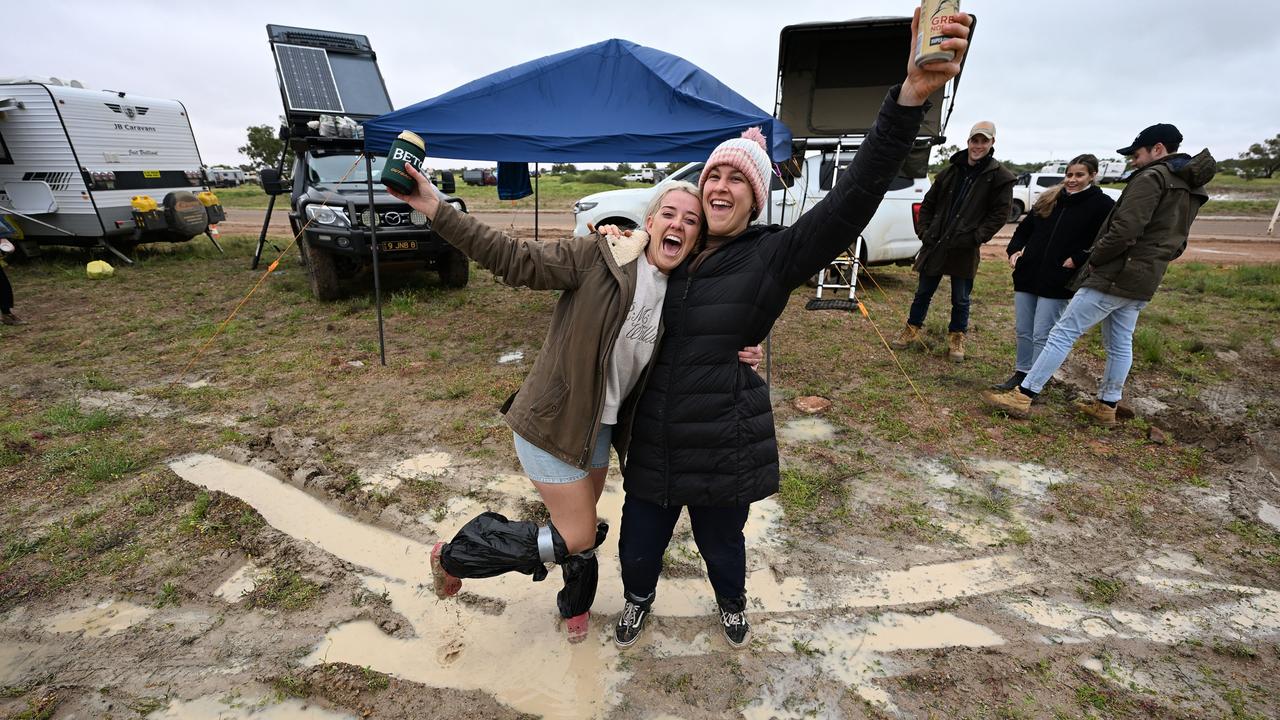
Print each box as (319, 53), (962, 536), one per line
(170, 455), (1038, 717)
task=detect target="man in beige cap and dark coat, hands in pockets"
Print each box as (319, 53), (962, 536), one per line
(891, 120), (1015, 363)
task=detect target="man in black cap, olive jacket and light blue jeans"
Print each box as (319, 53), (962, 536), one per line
(983, 123), (1216, 425)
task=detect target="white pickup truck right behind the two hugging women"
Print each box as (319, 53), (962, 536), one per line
(573, 150), (929, 265)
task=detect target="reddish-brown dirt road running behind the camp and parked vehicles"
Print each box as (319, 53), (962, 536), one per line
(221, 208), (1280, 265)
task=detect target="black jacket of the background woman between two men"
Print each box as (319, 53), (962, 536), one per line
(1005, 184), (1116, 300)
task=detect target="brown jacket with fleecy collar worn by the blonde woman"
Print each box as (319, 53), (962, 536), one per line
(433, 202), (662, 470)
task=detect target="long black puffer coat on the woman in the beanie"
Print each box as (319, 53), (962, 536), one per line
(623, 87), (924, 506)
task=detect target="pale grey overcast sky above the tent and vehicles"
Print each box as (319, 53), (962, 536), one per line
(0, 0), (1280, 165)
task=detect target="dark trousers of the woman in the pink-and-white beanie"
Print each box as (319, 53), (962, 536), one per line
(618, 496), (750, 610)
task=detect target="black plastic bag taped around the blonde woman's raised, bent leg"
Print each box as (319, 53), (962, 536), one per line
(440, 512), (568, 580)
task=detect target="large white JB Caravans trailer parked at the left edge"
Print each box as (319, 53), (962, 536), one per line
(0, 78), (224, 261)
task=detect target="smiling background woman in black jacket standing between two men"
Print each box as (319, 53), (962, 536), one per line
(992, 155), (1115, 389)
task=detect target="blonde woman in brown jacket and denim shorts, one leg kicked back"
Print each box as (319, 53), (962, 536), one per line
(392, 165), (759, 642)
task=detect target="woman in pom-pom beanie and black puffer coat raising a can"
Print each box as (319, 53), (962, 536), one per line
(614, 12), (970, 646)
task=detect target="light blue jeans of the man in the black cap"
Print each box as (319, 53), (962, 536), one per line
(1023, 287), (1147, 402)
